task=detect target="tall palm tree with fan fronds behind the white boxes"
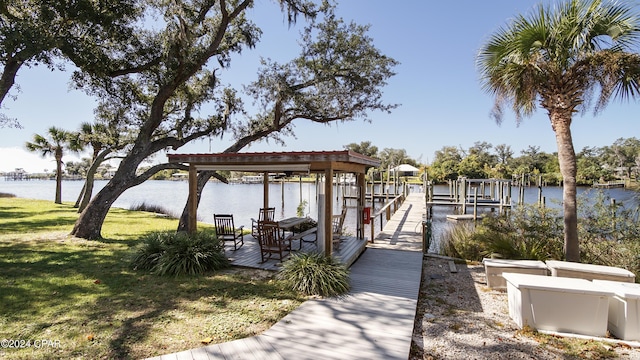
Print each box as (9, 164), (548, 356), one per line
(477, 0), (640, 261)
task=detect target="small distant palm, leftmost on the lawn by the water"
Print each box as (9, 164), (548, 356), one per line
(26, 126), (81, 204)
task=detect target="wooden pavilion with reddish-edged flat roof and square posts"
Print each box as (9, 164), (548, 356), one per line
(167, 150), (380, 255)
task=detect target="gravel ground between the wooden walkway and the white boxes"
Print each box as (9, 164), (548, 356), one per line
(410, 257), (640, 360)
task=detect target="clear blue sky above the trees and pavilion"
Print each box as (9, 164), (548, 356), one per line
(0, 0), (640, 172)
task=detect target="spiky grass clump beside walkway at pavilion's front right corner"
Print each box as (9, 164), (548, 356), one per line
(277, 253), (350, 296)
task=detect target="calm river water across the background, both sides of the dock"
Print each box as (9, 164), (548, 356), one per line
(0, 180), (638, 250)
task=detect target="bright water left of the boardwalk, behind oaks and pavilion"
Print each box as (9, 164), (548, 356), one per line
(0, 180), (381, 234)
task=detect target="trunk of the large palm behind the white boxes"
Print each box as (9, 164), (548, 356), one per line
(549, 112), (580, 262)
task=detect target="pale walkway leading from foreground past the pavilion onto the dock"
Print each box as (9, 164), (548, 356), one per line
(147, 193), (424, 360)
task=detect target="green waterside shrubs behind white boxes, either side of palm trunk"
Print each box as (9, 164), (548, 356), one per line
(440, 191), (640, 278)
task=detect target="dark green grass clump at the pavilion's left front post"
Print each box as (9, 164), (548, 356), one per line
(132, 231), (229, 276)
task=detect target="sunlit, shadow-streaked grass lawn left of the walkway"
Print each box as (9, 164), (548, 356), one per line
(0, 198), (304, 359)
